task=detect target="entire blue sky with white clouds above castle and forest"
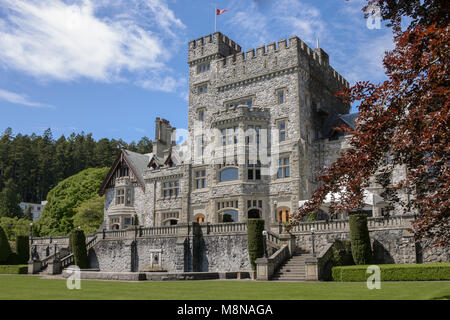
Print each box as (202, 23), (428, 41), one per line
(0, 0), (392, 142)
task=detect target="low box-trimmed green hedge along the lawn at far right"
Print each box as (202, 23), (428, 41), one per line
(332, 262), (450, 281)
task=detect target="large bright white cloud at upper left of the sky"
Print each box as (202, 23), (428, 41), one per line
(0, 0), (185, 91)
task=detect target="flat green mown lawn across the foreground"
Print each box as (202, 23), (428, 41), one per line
(0, 275), (450, 300)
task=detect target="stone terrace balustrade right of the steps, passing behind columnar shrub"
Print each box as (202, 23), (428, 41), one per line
(291, 215), (414, 234)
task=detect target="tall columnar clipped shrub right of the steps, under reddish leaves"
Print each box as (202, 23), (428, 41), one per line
(349, 213), (372, 265)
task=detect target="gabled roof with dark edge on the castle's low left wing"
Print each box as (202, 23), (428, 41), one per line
(98, 149), (153, 195)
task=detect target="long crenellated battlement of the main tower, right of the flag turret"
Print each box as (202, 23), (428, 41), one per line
(213, 36), (349, 87)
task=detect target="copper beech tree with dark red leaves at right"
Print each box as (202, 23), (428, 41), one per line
(291, 0), (450, 246)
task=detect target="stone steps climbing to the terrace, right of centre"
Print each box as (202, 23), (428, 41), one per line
(271, 250), (312, 281)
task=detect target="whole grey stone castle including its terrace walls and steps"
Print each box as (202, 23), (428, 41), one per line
(30, 32), (449, 280)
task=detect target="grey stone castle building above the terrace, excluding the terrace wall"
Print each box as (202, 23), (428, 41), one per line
(100, 32), (358, 229)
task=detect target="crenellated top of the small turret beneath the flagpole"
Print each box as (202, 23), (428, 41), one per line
(188, 31), (241, 63)
